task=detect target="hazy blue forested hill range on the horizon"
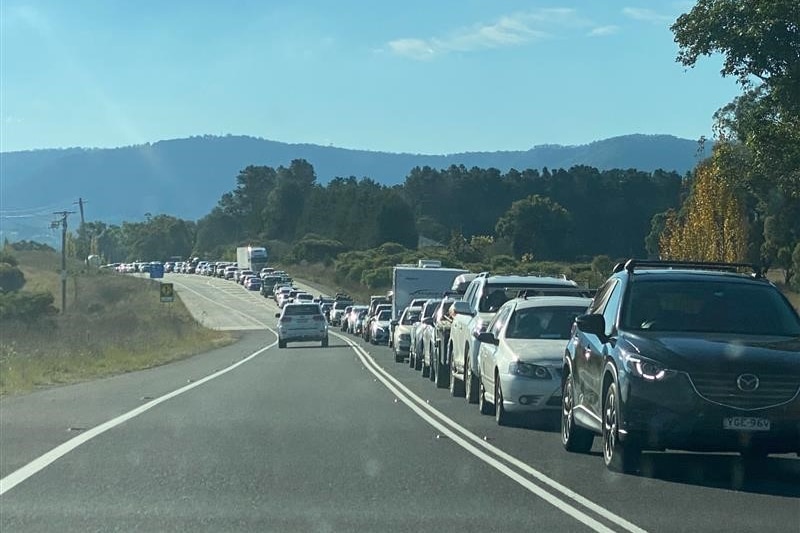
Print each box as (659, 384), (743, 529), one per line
(0, 135), (709, 239)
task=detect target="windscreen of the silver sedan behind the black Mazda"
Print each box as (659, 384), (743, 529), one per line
(506, 306), (586, 340)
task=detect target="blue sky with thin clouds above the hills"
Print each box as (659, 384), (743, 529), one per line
(0, 0), (740, 153)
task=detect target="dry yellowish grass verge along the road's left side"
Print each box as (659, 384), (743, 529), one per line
(0, 252), (233, 395)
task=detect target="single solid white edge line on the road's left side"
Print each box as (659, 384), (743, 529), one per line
(0, 341), (278, 496)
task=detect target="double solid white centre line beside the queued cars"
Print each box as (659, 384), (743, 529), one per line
(333, 333), (646, 533)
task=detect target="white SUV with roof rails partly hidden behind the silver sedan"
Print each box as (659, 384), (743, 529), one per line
(447, 272), (585, 403)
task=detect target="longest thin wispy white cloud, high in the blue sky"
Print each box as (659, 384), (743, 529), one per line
(386, 8), (591, 60)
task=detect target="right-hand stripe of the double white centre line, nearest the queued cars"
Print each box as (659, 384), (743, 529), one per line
(334, 333), (646, 533)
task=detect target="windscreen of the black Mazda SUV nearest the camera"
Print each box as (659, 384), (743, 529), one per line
(621, 279), (800, 336)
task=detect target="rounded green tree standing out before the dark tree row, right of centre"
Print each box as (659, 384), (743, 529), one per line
(495, 195), (572, 259)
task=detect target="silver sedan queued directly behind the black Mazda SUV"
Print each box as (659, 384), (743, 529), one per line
(478, 296), (592, 425)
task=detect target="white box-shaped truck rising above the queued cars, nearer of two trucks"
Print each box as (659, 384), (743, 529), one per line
(392, 259), (467, 320)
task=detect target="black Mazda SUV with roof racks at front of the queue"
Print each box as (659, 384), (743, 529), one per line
(561, 259), (800, 472)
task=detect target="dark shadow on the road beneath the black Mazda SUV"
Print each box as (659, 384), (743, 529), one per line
(638, 452), (800, 498)
